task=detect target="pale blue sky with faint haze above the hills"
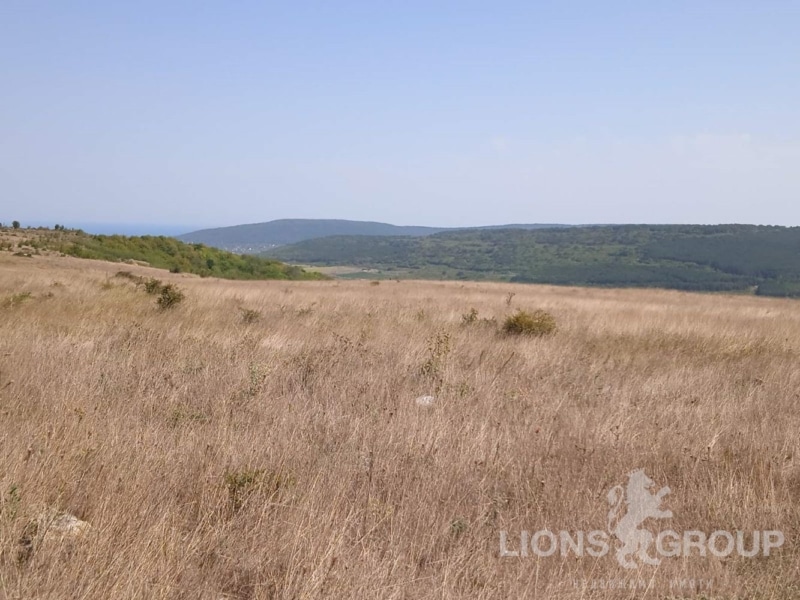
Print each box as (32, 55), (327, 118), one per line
(0, 0), (800, 229)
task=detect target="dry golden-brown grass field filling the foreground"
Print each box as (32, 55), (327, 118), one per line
(0, 252), (800, 600)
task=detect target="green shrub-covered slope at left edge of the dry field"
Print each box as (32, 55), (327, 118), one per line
(0, 229), (324, 280)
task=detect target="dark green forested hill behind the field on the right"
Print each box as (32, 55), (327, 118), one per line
(269, 225), (800, 296)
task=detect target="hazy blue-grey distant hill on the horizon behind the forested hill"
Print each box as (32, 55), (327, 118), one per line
(177, 219), (565, 254)
